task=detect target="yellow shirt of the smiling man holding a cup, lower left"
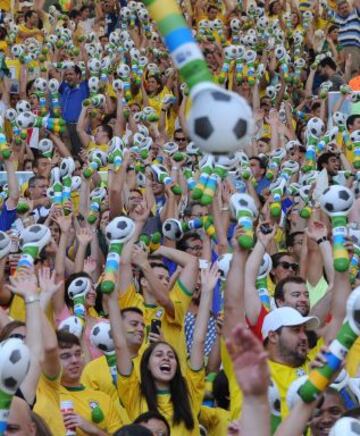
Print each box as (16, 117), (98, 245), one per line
(56, 385), (122, 435)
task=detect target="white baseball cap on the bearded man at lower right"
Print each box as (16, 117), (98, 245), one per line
(261, 307), (320, 340)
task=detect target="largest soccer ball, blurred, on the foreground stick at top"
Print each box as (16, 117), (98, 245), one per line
(188, 85), (254, 154)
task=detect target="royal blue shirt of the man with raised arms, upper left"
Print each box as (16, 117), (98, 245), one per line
(59, 80), (90, 123)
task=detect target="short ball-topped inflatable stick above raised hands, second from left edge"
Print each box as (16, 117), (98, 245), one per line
(17, 224), (51, 269)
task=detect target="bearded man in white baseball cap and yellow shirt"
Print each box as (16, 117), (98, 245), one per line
(261, 306), (319, 417)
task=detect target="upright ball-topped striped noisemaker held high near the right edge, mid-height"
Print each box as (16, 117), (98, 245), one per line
(319, 185), (354, 272)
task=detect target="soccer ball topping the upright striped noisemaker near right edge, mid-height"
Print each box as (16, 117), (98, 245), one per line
(319, 185), (354, 216)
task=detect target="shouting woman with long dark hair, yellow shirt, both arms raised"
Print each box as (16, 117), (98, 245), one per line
(108, 266), (218, 436)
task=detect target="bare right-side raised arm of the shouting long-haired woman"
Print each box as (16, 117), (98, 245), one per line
(190, 264), (219, 371)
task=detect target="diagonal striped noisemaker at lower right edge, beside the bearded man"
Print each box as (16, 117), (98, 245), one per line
(298, 287), (360, 403)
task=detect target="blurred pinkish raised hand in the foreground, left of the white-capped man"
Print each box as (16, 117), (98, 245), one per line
(226, 324), (270, 396)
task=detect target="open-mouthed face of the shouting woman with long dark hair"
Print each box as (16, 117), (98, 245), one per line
(148, 343), (177, 385)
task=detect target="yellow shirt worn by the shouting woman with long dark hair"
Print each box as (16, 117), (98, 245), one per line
(117, 366), (205, 436)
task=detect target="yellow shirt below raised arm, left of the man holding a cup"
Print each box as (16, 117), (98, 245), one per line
(34, 374), (65, 435)
